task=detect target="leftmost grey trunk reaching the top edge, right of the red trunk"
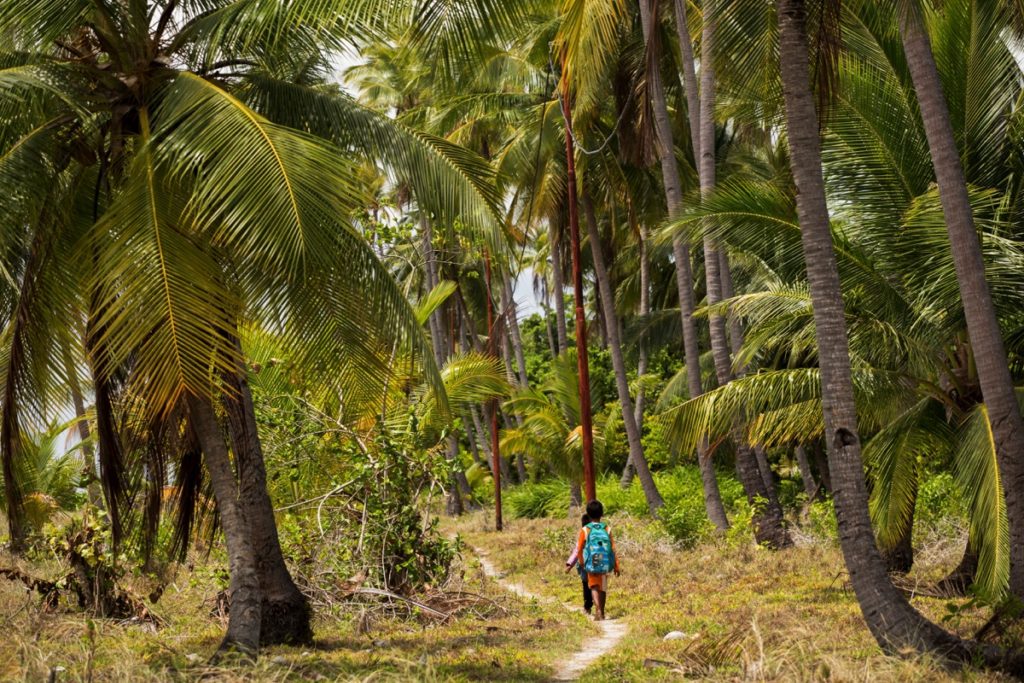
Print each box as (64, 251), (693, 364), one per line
(640, 0), (729, 530)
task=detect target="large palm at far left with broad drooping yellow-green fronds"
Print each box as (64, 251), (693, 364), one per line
(0, 0), (503, 651)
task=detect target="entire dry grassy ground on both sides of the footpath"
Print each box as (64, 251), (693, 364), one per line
(0, 513), (1015, 682)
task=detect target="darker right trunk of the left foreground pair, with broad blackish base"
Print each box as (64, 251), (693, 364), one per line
(223, 367), (313, 645)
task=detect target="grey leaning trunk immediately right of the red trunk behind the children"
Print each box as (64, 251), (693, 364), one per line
(580, 191), (665, 516)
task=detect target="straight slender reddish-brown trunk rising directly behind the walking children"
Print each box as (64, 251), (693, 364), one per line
(561, 72), (597, 502)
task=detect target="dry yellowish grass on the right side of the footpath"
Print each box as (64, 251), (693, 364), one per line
(451, 513), (1004, 681)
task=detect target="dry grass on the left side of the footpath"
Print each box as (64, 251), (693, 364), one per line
(0, 544), (595, 681)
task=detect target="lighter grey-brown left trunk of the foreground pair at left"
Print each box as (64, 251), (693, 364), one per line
(187, 395), (262, 657)
